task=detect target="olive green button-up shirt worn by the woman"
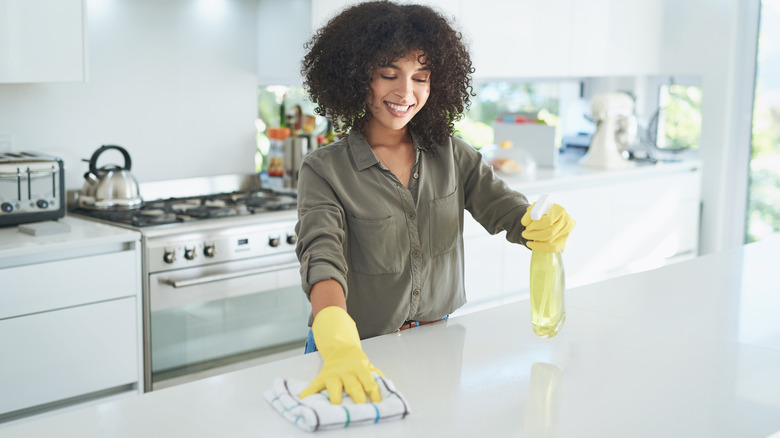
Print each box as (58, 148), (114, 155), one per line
(296, 132), (528, 338)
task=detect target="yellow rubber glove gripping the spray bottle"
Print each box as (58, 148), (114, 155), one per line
(520, 203), (577, 252)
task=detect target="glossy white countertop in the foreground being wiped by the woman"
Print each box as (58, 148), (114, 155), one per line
(0, 236), (780, 438)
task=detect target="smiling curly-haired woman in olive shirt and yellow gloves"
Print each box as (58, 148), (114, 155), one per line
(296, 1), (574, 403)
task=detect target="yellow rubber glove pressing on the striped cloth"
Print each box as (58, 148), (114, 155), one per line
(300, 306), (384, 404)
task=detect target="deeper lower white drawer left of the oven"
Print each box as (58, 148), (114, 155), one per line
(0, 297), (140, 414)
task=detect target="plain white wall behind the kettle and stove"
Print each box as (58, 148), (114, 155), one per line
(0, 0), (257, 189)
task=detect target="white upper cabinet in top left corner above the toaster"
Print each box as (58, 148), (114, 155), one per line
(0, 0), (85, 83)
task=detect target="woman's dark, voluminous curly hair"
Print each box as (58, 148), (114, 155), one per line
(301, 1), (474, 150)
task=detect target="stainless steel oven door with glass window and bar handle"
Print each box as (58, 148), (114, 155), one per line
(146, 253), (311, 389)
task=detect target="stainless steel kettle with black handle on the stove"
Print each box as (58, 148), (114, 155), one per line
(78, 145), (143, 210)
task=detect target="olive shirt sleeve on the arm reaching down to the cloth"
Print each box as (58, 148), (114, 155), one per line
(295, 157), (348, 297)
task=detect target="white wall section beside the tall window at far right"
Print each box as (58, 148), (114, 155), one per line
(661, 0), (760, 254)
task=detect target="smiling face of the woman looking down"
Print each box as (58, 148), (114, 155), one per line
(366, 52), (431, 135)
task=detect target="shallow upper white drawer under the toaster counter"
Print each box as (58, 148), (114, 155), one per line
(0, 251), (141, 319)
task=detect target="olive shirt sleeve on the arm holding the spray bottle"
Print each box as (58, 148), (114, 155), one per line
(453, 138), (529, 245)
